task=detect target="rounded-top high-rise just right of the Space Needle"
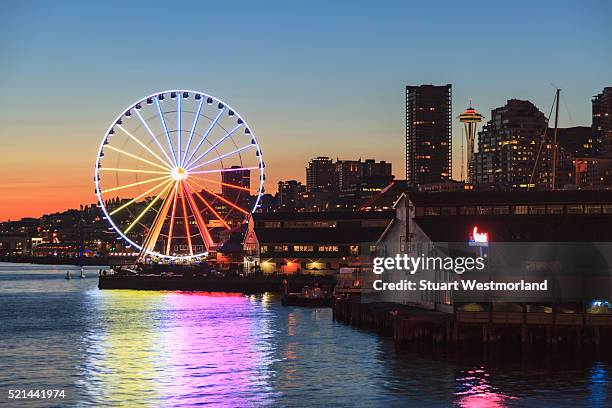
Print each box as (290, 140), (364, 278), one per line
(473, 99), (548, 190)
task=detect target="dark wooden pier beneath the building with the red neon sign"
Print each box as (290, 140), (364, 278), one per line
(334, 298), (612, 351)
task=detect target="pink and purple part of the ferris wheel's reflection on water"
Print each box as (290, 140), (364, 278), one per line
(155, 292), (271, 406)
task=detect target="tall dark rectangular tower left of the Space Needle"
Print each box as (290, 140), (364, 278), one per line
(406, 84), (452, 185)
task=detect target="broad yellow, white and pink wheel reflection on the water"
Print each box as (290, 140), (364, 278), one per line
(83, 291), (274, 406)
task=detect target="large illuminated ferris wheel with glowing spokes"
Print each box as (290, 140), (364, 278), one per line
(94, 90), (265, 260)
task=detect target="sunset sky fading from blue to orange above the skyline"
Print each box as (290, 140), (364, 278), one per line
(0, 1), (612, 221)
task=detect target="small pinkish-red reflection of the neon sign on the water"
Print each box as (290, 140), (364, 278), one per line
(455, 367), (517, 408)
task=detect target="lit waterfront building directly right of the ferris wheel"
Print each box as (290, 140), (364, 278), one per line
(244, 211), (395, 281)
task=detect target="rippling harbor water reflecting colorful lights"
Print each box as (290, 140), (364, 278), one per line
(0, 264), (612, 407)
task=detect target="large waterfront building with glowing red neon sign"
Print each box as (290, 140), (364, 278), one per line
(376, 191), (612, 312)
